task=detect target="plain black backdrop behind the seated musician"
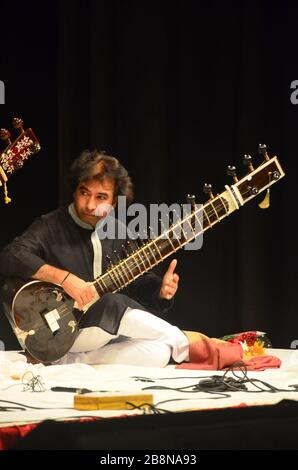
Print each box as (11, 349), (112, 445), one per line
(0, 0), (298, 347)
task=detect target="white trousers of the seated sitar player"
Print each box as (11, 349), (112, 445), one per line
(56, 308), (188, 367)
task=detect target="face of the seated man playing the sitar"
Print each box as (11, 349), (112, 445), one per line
(73, 178), (115, 227)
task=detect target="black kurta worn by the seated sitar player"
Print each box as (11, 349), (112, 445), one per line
(0, 207), (172, 334)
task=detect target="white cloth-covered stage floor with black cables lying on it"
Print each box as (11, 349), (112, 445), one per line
(0, 349), (298, 432)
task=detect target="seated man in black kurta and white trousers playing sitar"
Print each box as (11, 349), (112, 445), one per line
(0, 150), (188, 367)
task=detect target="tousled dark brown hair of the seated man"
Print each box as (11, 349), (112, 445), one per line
(69, 149), (133, 204)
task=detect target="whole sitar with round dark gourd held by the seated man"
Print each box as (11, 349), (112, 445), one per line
(2, 145), (285, 363)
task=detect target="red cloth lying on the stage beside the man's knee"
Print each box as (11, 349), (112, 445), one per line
(176, 335), (281, 370)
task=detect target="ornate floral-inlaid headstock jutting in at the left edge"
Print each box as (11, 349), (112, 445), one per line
(0, 118), (40, 204)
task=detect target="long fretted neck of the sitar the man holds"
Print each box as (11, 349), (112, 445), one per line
(93, 157), (284, 297)
